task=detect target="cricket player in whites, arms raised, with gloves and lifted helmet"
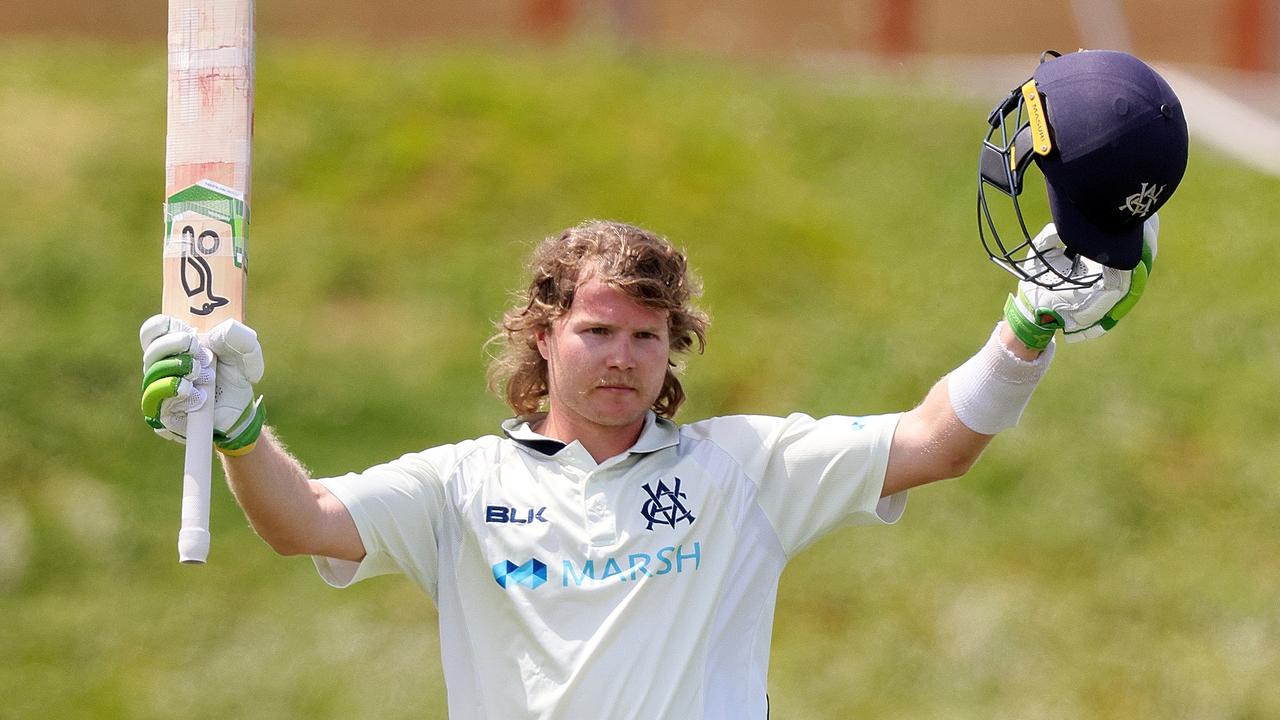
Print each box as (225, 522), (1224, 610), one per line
(141, 53), (1187, 720)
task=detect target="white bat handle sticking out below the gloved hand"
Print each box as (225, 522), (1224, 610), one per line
(178, 353), (216, 565)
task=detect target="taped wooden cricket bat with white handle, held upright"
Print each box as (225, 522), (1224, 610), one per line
(163, 0), (253, 564)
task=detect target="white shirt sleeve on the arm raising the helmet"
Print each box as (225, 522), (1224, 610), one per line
(704, 413), (906, 556)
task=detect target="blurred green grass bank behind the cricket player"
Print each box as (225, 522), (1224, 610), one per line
(0, 42), (1280, 719)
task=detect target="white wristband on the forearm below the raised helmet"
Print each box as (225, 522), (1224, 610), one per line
(947, 323), (1056, 436)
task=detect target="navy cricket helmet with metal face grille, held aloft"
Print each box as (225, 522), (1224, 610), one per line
(978, 50), (1187, 288)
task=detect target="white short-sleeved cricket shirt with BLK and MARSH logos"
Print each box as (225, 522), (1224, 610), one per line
(315, 413), (906, 720)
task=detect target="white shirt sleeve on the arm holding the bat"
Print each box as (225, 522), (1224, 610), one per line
(312, 447), (452, 600)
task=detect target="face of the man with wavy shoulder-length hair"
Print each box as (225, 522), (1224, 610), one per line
(538, 277), (671, 433)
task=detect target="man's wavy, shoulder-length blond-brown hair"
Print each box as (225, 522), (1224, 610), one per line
(489, 220), (709, 418)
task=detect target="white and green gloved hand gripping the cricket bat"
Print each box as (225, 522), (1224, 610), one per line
(138, 315), (266, 455)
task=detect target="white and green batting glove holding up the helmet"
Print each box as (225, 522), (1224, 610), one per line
(1005, 215), (1160, 350)
